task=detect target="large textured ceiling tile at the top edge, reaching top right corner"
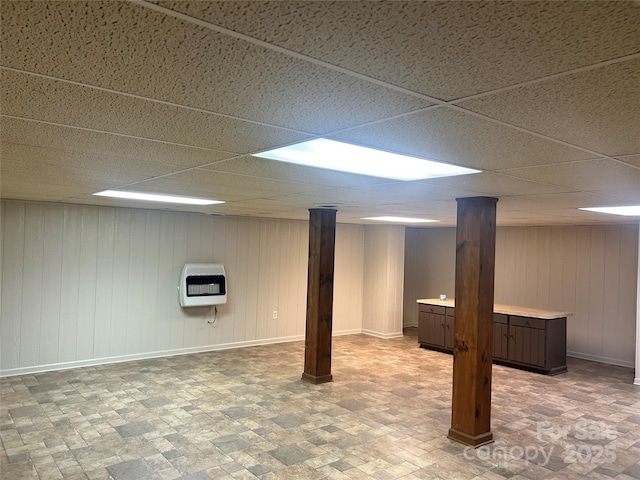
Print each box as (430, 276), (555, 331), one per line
(160, 1), (640, 99)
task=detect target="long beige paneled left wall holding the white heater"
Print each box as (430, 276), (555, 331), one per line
(0, 201), (364, 375)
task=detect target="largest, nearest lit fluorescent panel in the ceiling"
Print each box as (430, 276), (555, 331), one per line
(254, 138), (480, 180)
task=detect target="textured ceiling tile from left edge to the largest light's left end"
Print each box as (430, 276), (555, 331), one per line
(0, 70), (307, 153)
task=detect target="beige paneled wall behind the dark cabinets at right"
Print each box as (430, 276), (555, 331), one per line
(404, 225), (638, 367)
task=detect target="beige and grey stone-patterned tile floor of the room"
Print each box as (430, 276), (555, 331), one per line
(0, 335), (640, 480)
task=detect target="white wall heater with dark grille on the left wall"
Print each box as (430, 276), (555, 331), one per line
(178, 263), (227, 307)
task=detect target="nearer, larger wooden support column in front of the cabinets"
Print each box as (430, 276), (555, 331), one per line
(449, 197), (498, 447)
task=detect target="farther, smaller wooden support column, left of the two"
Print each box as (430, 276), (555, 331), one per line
(302, 209), (336, 384)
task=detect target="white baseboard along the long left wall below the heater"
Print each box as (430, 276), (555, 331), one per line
(0, 329), (362, 377)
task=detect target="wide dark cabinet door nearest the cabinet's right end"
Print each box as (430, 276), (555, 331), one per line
(509, 317), (545, 367)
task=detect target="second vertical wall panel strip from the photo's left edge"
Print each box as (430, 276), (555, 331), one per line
(20, 203), (44, 365)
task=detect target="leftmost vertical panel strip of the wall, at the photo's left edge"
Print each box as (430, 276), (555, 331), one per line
(0, 202), (26, 369)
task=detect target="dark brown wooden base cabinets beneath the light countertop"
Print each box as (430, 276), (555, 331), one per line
(418, 304), (567, 375)
